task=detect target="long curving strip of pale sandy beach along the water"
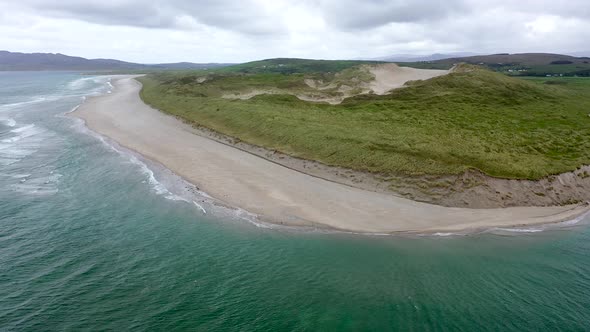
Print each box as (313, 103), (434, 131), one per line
(72, 77), (589, 233)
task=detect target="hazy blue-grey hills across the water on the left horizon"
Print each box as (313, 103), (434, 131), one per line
(0, 51), (234, 71)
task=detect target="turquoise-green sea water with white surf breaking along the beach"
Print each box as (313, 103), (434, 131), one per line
(0, 73), (590, 331)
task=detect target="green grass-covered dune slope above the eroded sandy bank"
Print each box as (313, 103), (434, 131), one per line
(141, 63), (590, 179)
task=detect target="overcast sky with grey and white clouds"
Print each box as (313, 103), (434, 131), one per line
(0, 0), (590, 63)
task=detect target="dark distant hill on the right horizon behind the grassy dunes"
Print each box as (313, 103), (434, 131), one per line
(400, 53), (590, 76)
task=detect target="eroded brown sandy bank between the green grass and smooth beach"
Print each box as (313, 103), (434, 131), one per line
(156, 107), (590, 209)
